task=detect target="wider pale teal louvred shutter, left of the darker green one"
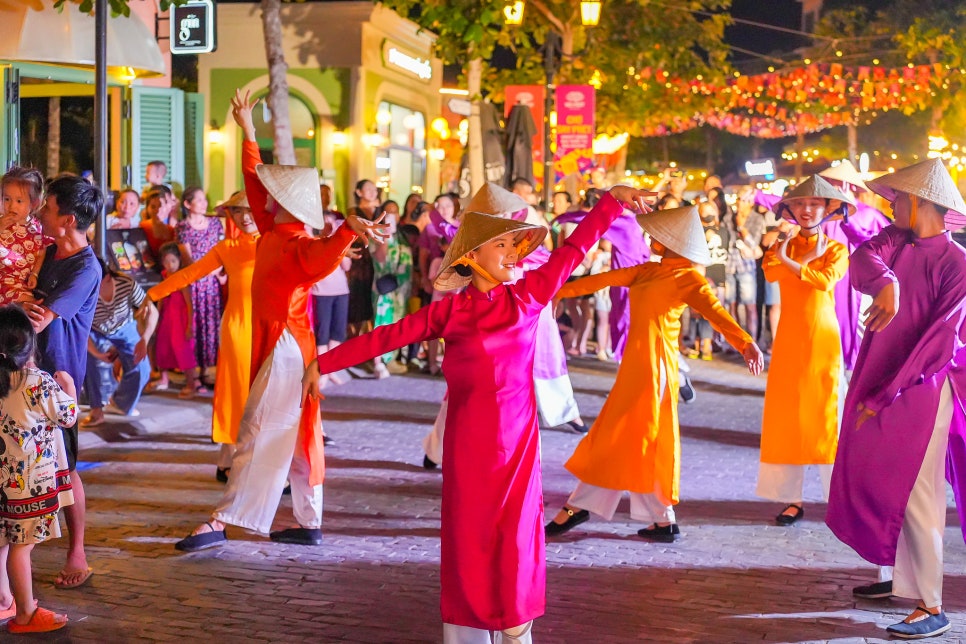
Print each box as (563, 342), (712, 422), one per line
(131, 87), (186, 192)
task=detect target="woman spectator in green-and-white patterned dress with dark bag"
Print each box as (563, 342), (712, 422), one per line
(369, 201), (413, 378)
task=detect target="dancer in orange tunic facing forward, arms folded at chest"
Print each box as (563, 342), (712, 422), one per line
(755, 175), (855, 526)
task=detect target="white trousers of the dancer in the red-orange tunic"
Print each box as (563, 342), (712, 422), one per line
(212, 330), (322, 534)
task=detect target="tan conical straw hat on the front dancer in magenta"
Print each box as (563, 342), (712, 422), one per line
(433, 211), (547, 291)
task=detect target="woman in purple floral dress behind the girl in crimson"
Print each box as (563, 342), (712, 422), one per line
(174, 187), (225, 378)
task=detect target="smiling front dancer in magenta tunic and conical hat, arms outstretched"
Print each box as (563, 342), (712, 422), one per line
(303, 181), (652, 643)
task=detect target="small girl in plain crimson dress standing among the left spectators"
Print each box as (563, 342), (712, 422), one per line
(150, 242), (198, 399)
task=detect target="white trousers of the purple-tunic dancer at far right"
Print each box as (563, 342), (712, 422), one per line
(879, 381), (953, 608)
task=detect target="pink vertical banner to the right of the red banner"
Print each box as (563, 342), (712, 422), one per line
(553, 85), (596, 181)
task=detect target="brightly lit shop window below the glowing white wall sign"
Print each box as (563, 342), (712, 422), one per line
(375, 101), (426, 203)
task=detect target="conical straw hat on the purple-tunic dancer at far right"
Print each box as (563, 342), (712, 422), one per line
(869, 159), (966, 230)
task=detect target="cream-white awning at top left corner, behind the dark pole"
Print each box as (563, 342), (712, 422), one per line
(0, 0), (165, 78)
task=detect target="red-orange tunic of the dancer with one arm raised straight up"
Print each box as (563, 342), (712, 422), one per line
(242, 141), (356, 485)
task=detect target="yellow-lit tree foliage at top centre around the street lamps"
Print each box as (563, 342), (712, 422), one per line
(384, 0), (730, 134)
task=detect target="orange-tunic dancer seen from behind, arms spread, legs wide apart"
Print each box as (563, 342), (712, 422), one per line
(545, 206), (764, 543)
